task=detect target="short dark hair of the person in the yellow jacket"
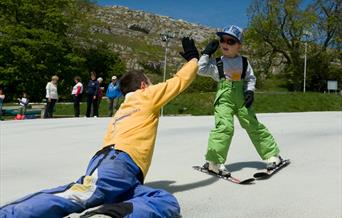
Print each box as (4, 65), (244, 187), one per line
(119, 71), (148, 95)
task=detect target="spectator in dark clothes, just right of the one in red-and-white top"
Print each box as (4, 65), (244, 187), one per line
(86, 71), (99, 117)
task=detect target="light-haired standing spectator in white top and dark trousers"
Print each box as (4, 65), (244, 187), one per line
(44, 75), (59, 118)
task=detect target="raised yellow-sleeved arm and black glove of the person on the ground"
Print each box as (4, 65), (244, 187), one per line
(146, 37), (199, 110)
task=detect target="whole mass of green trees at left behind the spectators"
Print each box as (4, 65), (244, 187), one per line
(0, 0), (124, 101)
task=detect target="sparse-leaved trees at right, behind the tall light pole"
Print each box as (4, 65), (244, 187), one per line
(246, 0), (342, 90)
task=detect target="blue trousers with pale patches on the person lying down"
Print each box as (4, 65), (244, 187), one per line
(0, 147), (180, 218)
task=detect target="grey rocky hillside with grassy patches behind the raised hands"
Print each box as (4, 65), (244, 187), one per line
(91, 6), (216, 72)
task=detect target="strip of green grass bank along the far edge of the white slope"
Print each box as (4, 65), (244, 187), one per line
(5, 92), (342, 119)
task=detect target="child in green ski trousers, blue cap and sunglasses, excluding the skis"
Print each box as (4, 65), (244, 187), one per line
(198, 25), (282, 176)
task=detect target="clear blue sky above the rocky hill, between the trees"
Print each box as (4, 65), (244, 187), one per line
(97, 0), (253, 28)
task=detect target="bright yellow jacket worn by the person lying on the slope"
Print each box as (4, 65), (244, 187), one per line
(103, 59), (198, 178)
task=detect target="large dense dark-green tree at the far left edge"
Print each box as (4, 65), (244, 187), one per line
(0, 0), (74, 100)
